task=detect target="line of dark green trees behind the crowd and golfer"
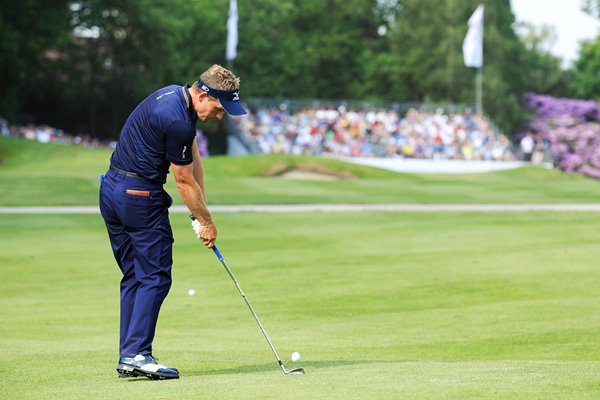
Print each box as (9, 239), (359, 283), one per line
(0, 0), (600, 138)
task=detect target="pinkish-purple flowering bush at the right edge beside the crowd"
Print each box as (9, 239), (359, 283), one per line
(525, 94), (600, 179)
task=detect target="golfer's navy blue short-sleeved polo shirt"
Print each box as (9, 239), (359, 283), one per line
(110, 85), (197, 183)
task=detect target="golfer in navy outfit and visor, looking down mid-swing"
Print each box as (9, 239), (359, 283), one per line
(100, 65), (246, 379)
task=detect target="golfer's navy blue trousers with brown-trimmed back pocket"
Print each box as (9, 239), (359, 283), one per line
(100, 170), (173, 357)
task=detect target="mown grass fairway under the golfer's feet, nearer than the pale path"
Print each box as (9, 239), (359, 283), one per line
(0, 213), (600, 400)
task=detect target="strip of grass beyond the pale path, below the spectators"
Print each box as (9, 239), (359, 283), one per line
(0, 137), (600, 206)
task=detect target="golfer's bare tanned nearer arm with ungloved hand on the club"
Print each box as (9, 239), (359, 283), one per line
(171, 163), (217, 247)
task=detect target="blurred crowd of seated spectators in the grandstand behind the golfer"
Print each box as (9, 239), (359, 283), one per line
(236, 106), (516, 161)
